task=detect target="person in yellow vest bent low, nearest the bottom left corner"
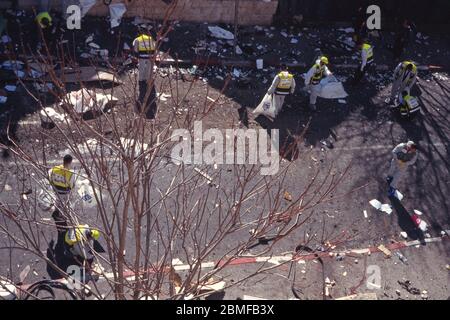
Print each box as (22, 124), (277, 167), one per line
(64, 224), (100, 260)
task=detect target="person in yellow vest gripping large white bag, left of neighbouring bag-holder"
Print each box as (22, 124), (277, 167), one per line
(267, 64), (295, 114)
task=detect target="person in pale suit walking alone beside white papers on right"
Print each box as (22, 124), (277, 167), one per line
(386, 141), (418, 196)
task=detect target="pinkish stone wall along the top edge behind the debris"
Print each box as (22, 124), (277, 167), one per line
(13, 0), (278, 25)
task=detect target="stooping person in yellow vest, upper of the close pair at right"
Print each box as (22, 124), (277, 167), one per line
(386, 61), (417, 104)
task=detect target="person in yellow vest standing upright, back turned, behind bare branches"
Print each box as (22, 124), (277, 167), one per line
(133, 28), (157, 119)
